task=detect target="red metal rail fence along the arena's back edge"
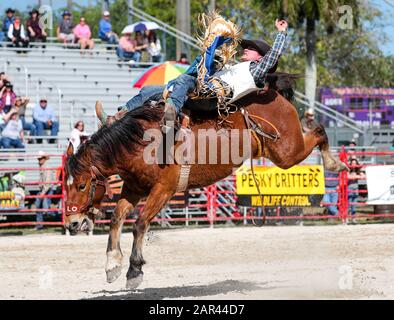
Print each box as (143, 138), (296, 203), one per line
(0, 148), (394, 227)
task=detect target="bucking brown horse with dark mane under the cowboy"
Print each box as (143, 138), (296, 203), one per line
(65, 90), (346, 288)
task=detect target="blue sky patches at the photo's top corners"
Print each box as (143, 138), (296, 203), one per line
(0, 0), (394, 55)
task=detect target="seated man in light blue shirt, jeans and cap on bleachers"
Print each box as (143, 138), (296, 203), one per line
(33, 97), (59, 143)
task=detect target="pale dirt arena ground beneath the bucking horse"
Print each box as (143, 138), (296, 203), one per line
(0, 224), (394, 299)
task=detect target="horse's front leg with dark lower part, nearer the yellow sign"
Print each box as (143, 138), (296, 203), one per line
(126, 184), (175, 289)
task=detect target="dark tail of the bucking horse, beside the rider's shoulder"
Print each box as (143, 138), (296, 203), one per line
(266, 72), (304, 103)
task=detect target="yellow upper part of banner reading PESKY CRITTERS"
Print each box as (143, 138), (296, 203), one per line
(236, 165), (325, 195)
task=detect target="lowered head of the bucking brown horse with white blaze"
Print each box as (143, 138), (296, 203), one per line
(64, 143), (111, 235)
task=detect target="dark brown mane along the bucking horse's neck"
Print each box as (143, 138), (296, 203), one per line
(66, 104), (163, 177)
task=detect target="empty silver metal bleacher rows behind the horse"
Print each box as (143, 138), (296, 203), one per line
(0, 43), (153, 185)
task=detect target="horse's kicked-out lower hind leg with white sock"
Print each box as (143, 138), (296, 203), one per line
(310, 124), (349, 172)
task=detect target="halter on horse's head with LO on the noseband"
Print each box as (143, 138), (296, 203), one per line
(65, 166), (113, 216)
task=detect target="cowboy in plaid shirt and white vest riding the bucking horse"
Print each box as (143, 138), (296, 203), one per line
(97, 15), (288, 124)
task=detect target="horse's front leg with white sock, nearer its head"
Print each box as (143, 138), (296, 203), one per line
(105, 190), (139, 283)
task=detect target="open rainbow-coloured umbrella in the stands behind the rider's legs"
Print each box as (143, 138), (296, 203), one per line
(133, 61), (189, 88)
